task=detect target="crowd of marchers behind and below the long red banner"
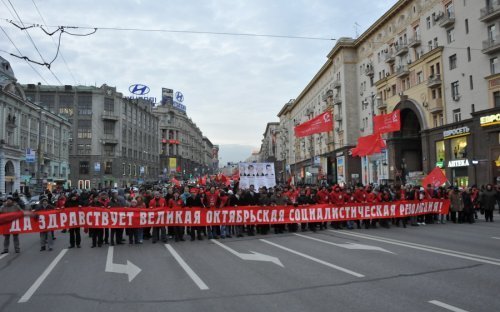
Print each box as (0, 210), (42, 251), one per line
(0, 183), (500, 254)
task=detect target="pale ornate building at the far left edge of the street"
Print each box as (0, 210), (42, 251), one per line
(0, 57), (71, 193)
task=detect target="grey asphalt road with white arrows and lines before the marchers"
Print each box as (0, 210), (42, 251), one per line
(0, 219), (500, 312)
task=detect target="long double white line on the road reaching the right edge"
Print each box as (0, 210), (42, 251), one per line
(329, 230), (500, 266)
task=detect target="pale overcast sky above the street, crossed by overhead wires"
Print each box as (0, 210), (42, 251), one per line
(0, 0), (396, 163)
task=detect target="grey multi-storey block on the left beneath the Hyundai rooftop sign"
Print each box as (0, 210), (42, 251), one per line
(23, 84), (160, 189)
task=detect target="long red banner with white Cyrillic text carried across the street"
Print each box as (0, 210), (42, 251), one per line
(0, 199), (450, 234)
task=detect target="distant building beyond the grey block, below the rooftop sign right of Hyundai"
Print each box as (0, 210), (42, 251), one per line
(153, 92), (218, 179)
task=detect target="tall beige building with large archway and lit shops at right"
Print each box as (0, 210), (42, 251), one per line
(270, 0), (500, 186)
